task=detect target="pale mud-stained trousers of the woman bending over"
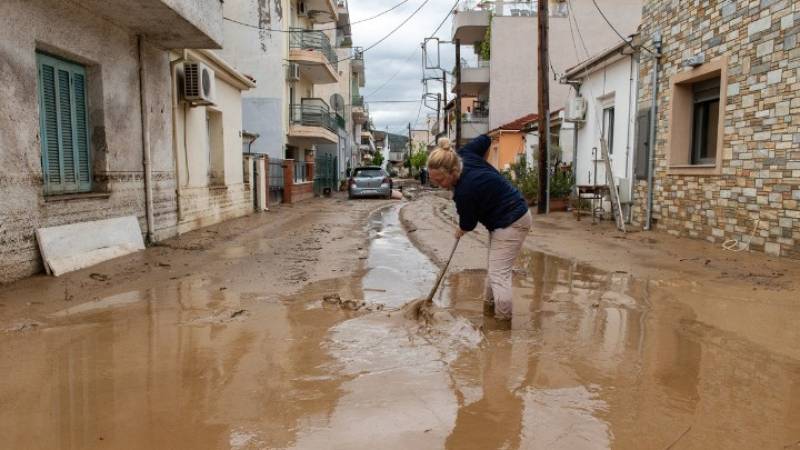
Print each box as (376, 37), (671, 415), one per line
(484, 211), (533, 319)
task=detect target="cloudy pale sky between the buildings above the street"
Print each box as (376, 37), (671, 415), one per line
(349, 0), (469, 133)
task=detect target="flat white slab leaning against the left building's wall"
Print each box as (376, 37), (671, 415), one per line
(36, 216), (144, 276)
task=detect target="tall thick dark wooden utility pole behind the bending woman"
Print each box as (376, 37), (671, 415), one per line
(536, 0), (550, 214)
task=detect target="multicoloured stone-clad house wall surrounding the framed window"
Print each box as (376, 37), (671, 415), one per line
(633, 0), (800, 258)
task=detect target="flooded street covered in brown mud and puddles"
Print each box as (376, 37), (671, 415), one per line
(0, 198), (800, 449)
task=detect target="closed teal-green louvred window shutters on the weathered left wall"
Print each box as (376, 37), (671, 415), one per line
(36, 53), (92, 194)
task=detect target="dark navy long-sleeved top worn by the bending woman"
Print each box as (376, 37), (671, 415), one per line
(453, 135), (528, 231)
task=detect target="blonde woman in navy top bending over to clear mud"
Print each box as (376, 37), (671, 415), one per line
(428, 135), (531, 320)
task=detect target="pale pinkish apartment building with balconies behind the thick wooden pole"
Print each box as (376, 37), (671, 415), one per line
(452, 0), (642, 132)
